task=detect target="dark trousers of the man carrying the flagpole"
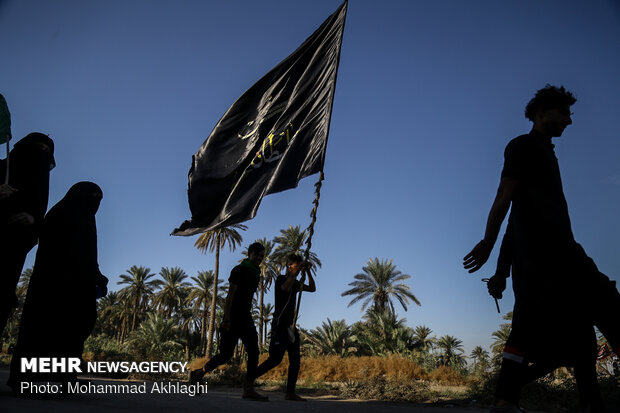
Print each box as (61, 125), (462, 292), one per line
(256, 327), (301, 393)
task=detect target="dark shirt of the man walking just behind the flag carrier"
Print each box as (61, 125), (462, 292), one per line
(228, 259), (260, 322)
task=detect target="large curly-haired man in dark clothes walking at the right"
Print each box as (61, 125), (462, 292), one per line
(464, 85), (618, 412)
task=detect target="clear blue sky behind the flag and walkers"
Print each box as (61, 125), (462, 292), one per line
(0, 0), (620, 352)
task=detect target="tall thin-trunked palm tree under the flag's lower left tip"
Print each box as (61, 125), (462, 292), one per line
(194, 224), (247, 358)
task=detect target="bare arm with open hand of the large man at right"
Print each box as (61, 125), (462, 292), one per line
(463, 176), (517, 273)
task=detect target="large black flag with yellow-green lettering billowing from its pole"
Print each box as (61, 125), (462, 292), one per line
(172, 1), (347, 236)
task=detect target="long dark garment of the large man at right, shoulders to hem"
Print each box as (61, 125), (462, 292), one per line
(498, 131), (595, 366)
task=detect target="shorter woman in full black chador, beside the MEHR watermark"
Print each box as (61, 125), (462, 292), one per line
(8, 182), (108, 391)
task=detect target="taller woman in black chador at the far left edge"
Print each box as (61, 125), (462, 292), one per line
(0, 133), (56, 335)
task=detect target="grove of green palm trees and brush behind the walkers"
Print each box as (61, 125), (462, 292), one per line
(2, 225), (616, 386)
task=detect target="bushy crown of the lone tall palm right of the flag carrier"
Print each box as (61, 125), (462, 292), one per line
(341, 258), (420, 312)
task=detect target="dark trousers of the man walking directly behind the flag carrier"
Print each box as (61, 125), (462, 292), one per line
(204, 320), (258, 380)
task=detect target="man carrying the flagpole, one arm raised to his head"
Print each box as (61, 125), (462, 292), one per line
(256, 254), (316, 401)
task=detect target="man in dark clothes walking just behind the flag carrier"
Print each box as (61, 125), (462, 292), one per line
(189, 242), (268, 401)
